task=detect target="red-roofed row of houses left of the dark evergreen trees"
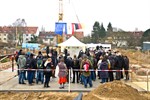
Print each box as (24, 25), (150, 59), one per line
(0, 26), (84, 45)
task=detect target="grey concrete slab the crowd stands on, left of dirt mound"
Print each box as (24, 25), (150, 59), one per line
(0, 76), (100, 92)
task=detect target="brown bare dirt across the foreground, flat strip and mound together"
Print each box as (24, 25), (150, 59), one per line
(0, 81), (150, 100)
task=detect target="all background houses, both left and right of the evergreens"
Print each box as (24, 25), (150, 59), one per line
(0, 26), (143, 47)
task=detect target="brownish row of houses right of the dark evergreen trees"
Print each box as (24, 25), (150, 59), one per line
(105, 31), (144, 47)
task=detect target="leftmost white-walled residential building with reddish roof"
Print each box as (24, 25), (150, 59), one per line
(0, 26), (38, 43)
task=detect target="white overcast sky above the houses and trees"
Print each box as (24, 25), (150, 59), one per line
(0, 0), (150, 34)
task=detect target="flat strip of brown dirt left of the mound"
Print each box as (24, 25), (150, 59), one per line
(0, 92), (78, 100)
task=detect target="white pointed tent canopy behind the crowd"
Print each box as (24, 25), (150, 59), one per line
(58, 36), (86, 57)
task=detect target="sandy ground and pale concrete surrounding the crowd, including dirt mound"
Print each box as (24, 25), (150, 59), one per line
(0, 49), (150, 100)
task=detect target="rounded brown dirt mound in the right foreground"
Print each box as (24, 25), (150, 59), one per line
(83, 81), (147, 100)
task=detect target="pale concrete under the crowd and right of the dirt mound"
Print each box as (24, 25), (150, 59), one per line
(0, 66), (147, 92)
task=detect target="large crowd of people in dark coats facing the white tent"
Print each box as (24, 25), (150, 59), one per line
(15, 46), (129, 89)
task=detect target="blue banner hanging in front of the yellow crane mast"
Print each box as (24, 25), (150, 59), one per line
(55, 22), (67, 35)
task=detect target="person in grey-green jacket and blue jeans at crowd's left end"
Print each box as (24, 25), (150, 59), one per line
(17, 52), (26, 84)
